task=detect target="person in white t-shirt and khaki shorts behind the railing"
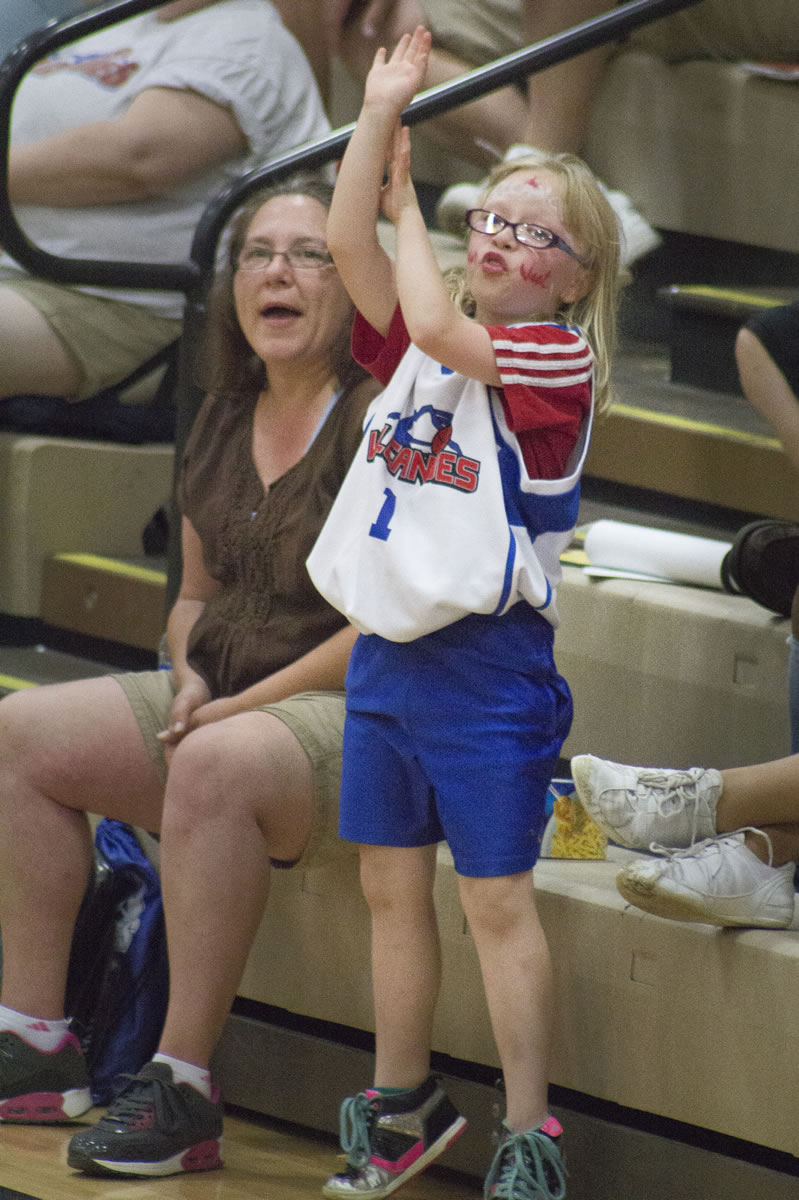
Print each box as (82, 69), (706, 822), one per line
(0, 0), (330, 400)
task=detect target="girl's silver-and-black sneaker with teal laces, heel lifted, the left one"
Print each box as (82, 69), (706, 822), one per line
(322, 1075), (467, 1200)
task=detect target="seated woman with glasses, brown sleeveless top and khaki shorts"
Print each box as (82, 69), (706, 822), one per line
(0, 178), (378, 1176)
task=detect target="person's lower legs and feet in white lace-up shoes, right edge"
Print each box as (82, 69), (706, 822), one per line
(571, 755), (799, 929)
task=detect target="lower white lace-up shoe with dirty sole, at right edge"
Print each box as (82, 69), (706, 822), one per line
(615, 829), (795, 929)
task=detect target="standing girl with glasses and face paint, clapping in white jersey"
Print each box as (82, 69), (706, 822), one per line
(308, 26), (618, 1200)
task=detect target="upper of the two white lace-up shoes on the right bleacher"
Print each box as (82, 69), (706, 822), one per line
(571, 754), (721, 850)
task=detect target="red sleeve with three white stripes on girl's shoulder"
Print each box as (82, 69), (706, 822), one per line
(479, 323), (594, 479)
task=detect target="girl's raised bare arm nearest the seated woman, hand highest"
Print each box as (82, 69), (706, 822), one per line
(328, 25), (431, 334)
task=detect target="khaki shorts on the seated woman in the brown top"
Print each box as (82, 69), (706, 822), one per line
(113, 671), (356, 868)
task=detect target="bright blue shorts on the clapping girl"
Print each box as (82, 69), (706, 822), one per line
(338, 604), (572, 876)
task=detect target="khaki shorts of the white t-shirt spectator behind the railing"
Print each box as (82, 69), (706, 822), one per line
(0, 271), (182, 400)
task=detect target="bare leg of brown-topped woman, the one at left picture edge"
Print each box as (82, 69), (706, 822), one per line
(0, 678), (162, 1019)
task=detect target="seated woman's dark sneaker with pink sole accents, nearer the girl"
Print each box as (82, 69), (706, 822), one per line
(67, 1062), (222, 1177)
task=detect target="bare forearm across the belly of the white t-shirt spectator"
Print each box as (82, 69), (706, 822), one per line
(8, 88), (247, 208)
